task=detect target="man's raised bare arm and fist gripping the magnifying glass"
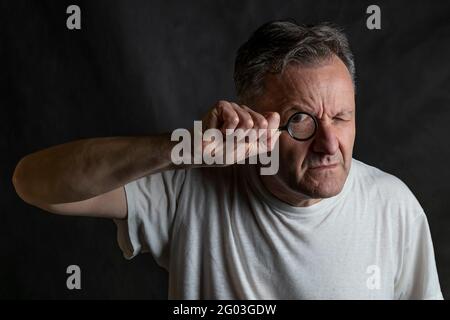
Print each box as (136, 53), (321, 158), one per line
(13, 101), (279, 219)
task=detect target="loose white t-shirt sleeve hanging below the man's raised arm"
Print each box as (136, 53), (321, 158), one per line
(114, 169), (187, 269)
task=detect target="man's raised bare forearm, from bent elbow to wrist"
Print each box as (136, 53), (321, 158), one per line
(13, 135), (174, 203)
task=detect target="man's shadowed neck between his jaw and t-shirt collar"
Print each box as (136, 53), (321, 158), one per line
(258, 169), (322, 207)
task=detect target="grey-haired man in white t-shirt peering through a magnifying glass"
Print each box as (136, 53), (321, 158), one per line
(13, 21), (442, 299)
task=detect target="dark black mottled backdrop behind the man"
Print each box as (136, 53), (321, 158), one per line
(0, 0), (450, 299)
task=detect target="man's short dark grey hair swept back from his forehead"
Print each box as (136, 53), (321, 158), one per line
(234, 21), (355, 101)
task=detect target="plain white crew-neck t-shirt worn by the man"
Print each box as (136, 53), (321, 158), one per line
(116, 159), (443, 299)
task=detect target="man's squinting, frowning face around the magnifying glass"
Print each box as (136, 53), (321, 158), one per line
(253, 56), (355, 198)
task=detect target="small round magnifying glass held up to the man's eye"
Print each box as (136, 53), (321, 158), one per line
(278, 111), (318, 141)
